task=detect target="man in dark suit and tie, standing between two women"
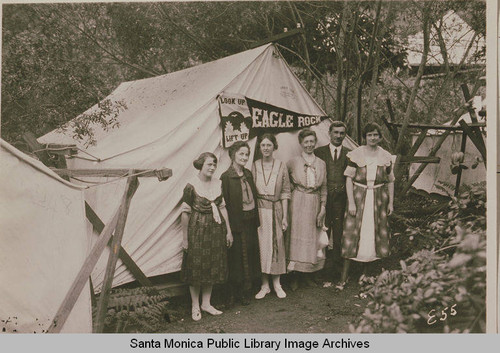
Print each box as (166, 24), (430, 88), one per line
(314, 121), (350, 279)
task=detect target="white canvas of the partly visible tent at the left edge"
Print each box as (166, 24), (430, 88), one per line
(0, 140), (92, 333)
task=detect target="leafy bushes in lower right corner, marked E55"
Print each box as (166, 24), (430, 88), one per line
(351, 184), (486, 332)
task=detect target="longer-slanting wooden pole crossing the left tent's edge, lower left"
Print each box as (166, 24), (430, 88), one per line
(47, 207), (120, 333)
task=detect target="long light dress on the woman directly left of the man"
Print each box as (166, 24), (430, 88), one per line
(287, 156), (327, 272)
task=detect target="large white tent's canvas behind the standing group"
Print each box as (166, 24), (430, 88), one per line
(39, 45), (355, 289)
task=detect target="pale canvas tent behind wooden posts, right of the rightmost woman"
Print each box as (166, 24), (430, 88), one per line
(410, 96), (486, 195)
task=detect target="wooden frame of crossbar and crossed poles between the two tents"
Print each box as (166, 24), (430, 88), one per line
(24, 134), (172, 333)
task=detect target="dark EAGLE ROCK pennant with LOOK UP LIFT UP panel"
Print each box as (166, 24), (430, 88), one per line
(219, 94), (327, 148)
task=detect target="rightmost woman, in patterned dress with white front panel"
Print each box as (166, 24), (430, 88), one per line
(337, 123), (394, 290)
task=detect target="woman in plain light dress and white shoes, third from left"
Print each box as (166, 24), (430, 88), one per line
(252, 134), (290, 299)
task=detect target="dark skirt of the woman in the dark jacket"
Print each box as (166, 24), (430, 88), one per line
(228, 211), (261, 290)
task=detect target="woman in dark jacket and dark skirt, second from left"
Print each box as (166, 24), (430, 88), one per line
(221, 141), (260, 305)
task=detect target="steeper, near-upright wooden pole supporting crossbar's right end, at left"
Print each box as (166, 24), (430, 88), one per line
(94, 174), (139, 333)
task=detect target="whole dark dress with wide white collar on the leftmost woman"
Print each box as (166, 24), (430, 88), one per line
(181, 178), (228, 285)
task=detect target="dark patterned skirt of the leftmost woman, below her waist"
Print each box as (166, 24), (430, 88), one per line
(181, 209), (228, 285)
